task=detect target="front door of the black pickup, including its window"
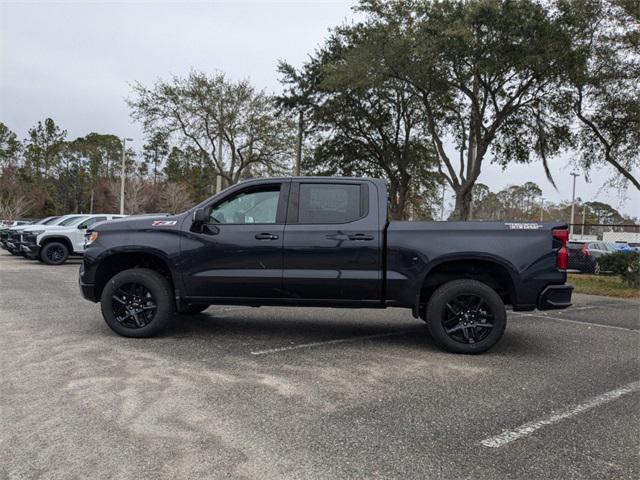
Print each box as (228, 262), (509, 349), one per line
(181, 182), (289, 301)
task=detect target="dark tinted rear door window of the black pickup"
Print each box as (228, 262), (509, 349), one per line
(298, 183), (363, 223)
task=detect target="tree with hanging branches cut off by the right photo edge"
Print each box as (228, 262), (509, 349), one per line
(557, 0), (640, 190)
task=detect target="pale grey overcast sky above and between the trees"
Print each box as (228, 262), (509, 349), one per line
(0, 0), (640, 216)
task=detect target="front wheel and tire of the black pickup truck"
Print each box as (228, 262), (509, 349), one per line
(100, 268), (175, 338)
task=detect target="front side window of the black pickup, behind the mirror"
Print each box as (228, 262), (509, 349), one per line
(210, 185), (280, 224)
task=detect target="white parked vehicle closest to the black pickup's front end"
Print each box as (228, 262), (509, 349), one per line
(20, 214), (124, 265)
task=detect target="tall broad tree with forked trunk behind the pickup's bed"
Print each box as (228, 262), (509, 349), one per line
(336, 0), (573, 219)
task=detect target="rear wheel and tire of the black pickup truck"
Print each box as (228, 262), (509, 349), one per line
(424, 279), (507, 354)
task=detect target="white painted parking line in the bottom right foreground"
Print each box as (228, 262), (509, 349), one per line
(480, 381), (640, 448)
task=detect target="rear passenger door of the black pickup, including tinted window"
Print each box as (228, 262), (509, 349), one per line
(283, 179), (382, 305)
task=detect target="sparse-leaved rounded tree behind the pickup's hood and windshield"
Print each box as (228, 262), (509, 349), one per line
(128, 71), (293, 185)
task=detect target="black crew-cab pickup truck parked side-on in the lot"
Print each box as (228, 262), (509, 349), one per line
(80, 177), (573, 353)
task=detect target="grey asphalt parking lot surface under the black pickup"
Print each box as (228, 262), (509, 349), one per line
(0, 251), (640, 479)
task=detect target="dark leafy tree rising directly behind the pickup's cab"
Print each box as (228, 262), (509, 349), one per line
(280, 34), (438, 219)
